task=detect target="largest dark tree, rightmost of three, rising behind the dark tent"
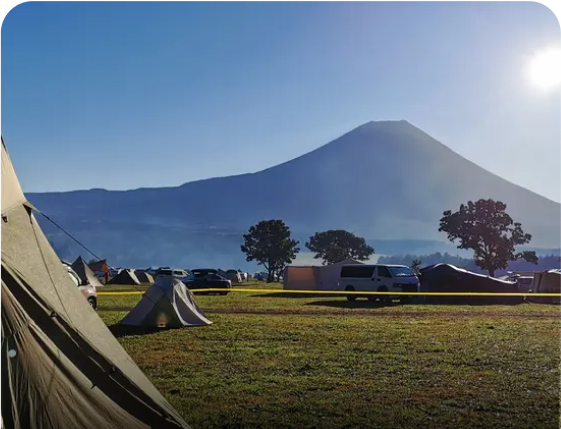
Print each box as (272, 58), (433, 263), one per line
(438, 199), (538, 276)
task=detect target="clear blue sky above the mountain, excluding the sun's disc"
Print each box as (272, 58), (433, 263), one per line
(0, 1), (561, 201)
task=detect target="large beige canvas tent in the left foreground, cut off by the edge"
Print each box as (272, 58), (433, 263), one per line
(0, 138), (189, 429)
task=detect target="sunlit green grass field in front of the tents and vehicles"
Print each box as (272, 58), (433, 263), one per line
(99, 283), (561, 429)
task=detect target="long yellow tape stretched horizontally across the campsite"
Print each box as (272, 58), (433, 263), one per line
(97, 288), (561, 298)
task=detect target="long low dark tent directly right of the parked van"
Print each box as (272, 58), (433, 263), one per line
(420, 264), (523, 304)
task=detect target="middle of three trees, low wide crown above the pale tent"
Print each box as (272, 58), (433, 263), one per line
(306, 229), (374, 265)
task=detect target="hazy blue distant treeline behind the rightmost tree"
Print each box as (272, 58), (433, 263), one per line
(378, 252), (561, 276)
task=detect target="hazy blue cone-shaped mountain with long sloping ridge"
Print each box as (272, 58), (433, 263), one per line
(24, 121), (561, 266)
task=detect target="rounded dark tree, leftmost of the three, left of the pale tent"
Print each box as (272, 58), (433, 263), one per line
(241, 219), (300, 283)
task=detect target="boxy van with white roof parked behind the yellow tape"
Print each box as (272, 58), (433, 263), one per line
(339, 264), (420, 302)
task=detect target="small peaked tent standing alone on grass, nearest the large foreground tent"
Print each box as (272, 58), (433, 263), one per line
(120, 276), (212, 328)
